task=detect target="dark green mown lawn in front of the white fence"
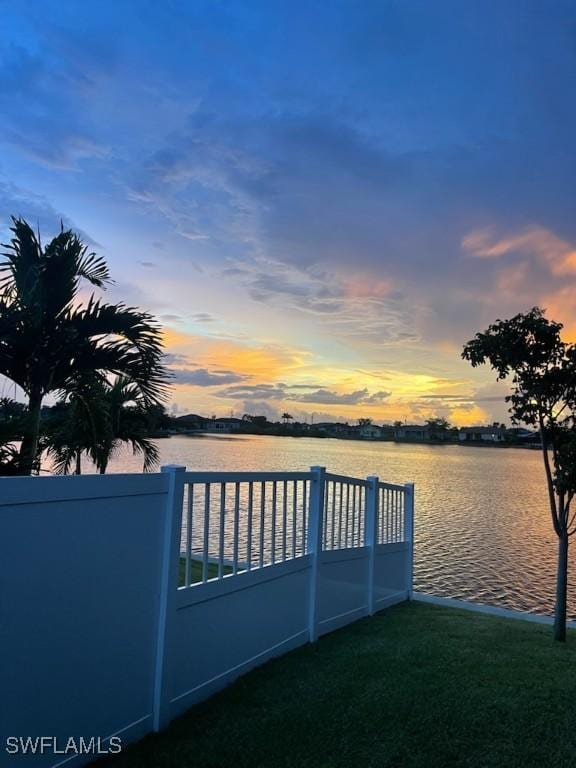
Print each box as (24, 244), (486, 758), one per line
(97, 603), (576, 768)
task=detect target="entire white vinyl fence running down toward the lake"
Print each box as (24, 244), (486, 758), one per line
(0, 466), (414, 766)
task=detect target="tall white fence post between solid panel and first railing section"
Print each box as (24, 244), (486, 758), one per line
(152, 464), (186, 731)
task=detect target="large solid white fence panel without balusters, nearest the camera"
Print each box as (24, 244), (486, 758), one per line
(0, 475), (167, 768)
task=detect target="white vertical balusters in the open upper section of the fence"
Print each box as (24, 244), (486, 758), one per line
(179, 468), (409, 588)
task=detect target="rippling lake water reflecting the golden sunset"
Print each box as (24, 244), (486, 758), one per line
(101, 436), (576, 618)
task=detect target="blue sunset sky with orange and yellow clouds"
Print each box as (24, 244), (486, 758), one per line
(0, 0), (576, 425)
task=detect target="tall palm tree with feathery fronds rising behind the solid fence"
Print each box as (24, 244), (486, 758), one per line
(0, 218), (168, 475)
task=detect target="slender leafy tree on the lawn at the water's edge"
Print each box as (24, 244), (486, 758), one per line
(462, 307), (576, 641)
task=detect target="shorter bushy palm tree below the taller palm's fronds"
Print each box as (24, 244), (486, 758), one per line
(45, 377), (159, 475)
